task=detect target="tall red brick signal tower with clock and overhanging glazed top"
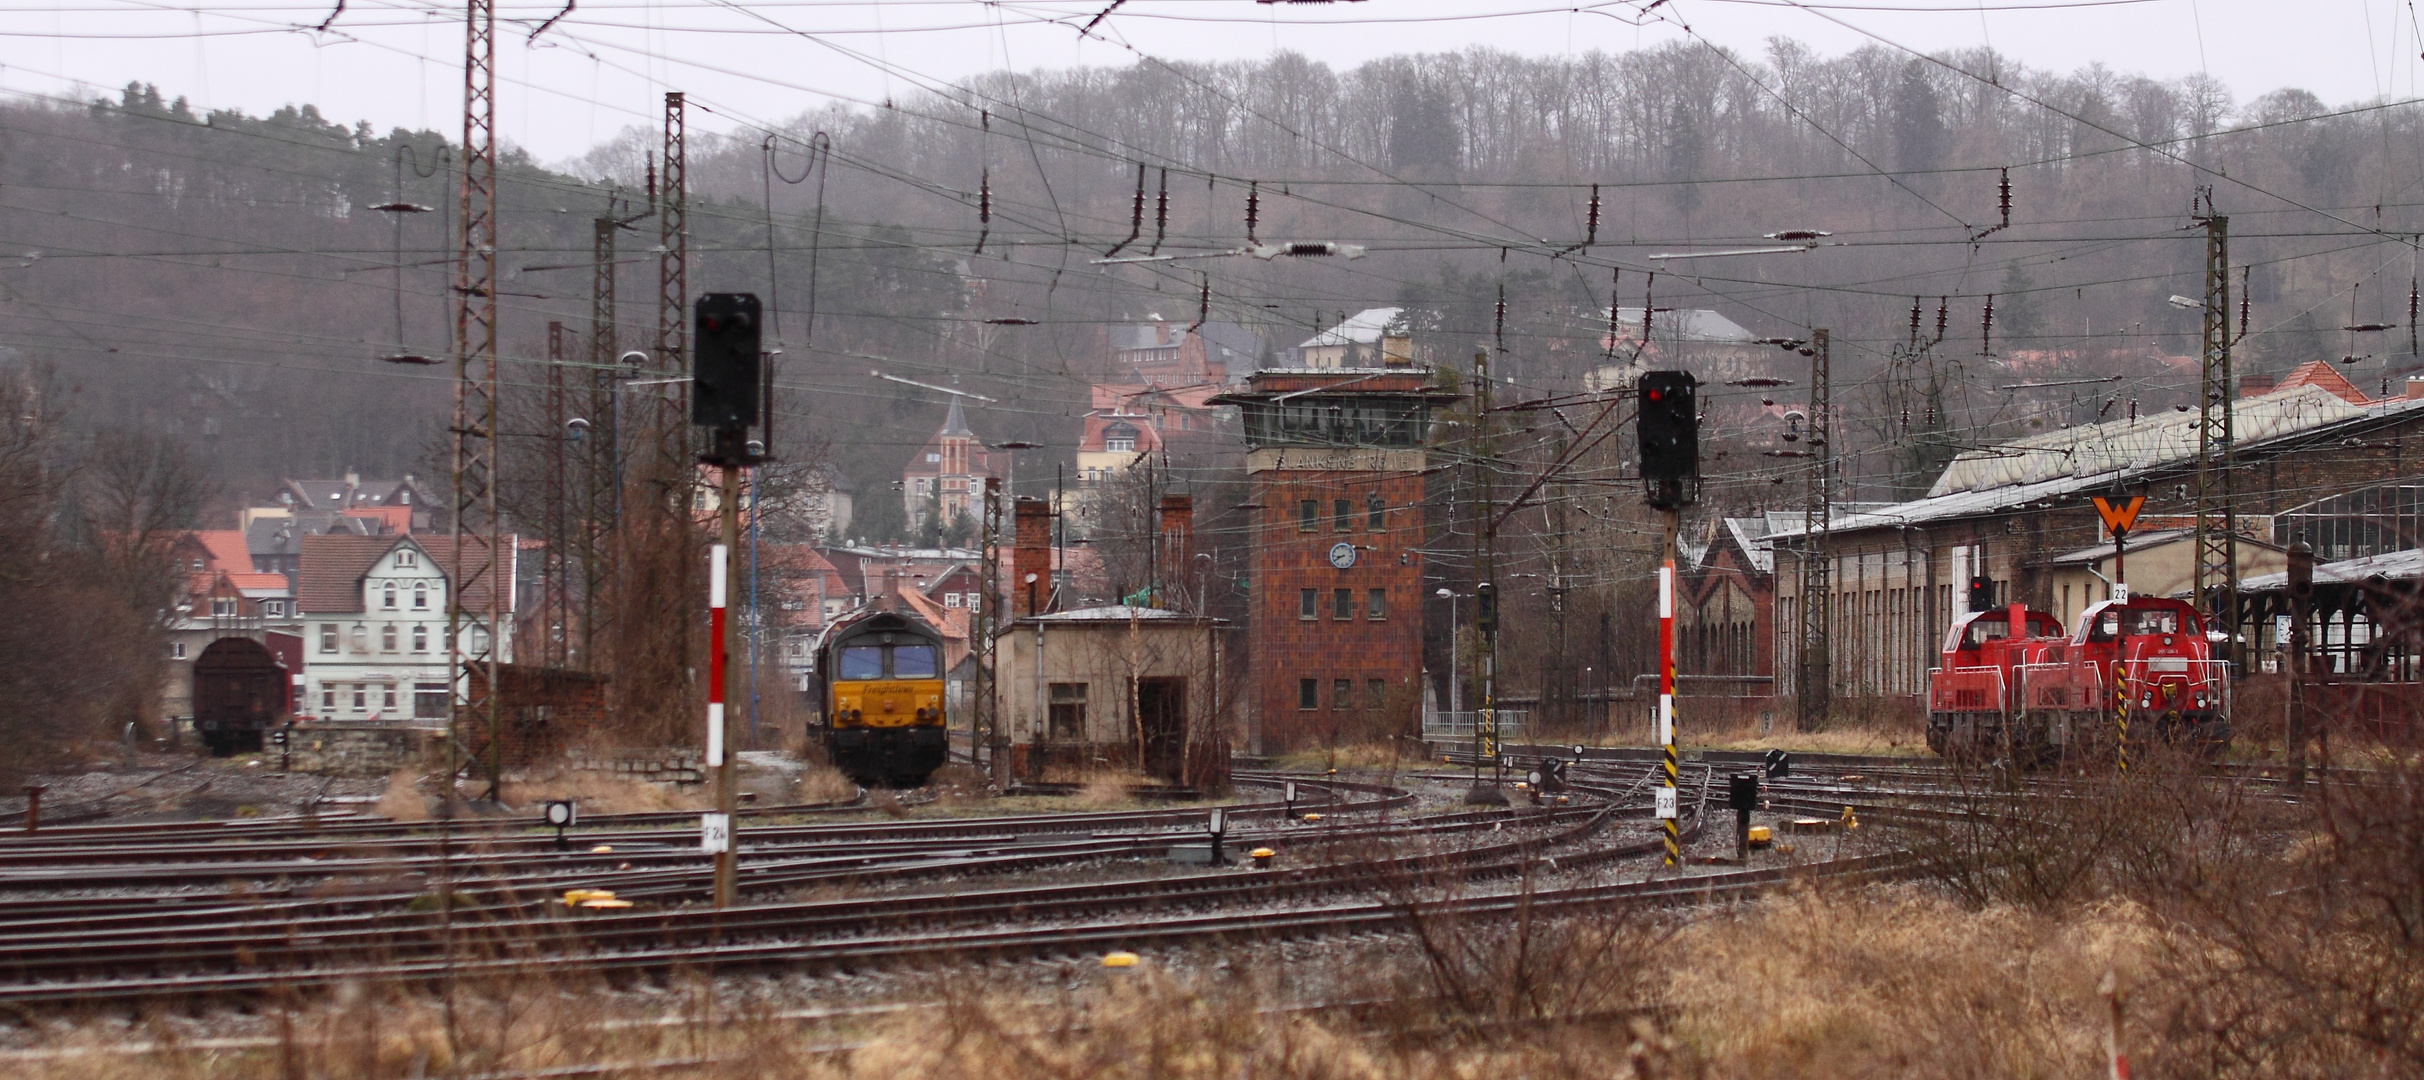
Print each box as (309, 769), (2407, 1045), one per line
(1212, 363), (1459, 753)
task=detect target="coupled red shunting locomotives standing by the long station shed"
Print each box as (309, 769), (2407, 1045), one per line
(1927, 596), (2230, 765)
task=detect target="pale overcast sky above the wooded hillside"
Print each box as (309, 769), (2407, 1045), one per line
(0, 0), (2424, 162)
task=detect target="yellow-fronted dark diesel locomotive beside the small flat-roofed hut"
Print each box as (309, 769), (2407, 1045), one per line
(810, 608), (950, 787)
